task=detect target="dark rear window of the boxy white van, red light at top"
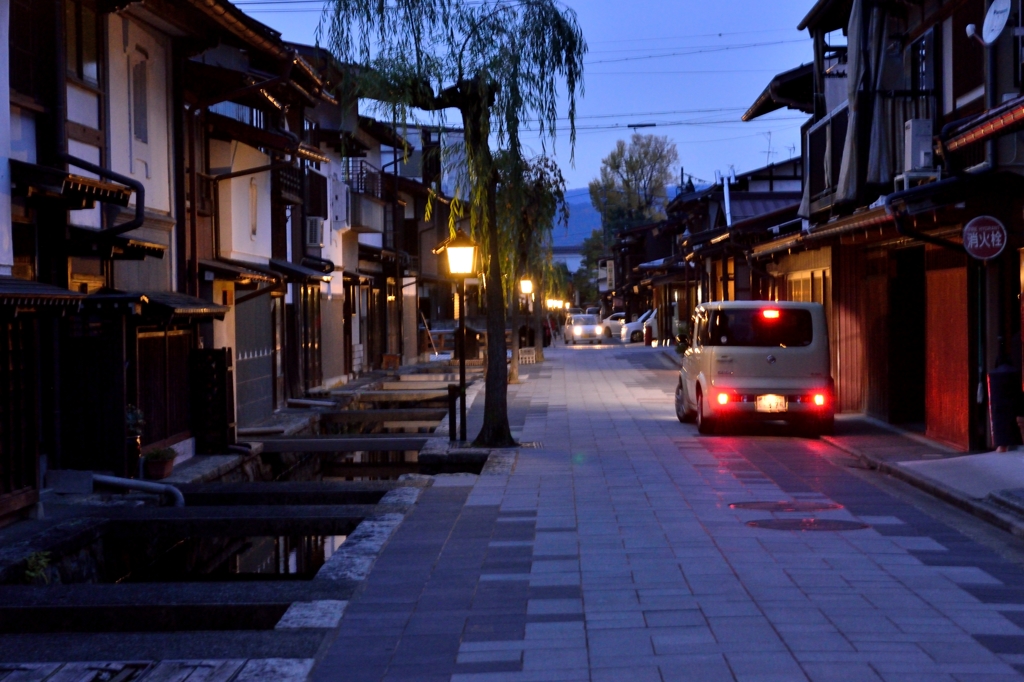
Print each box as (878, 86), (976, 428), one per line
(709, 308), (814, 348)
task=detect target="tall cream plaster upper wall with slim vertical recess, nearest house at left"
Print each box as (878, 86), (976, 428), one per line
(106, 14), (173, 214)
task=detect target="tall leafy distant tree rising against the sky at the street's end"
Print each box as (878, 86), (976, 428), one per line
(590, 133), (679, 245)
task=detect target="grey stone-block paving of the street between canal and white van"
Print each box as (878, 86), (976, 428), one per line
(312, 346), (1024, 682)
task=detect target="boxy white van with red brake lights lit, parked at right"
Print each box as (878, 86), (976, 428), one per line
(676, 301), (836, 436)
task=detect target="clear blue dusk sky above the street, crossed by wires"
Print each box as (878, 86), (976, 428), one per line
(237, 0), (813, 187)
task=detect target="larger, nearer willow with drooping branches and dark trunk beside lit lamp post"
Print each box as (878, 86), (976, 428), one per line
(322, 0), (587, 446)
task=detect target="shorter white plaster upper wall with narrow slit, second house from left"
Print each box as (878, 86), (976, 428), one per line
(210, 140), (272, 263)
